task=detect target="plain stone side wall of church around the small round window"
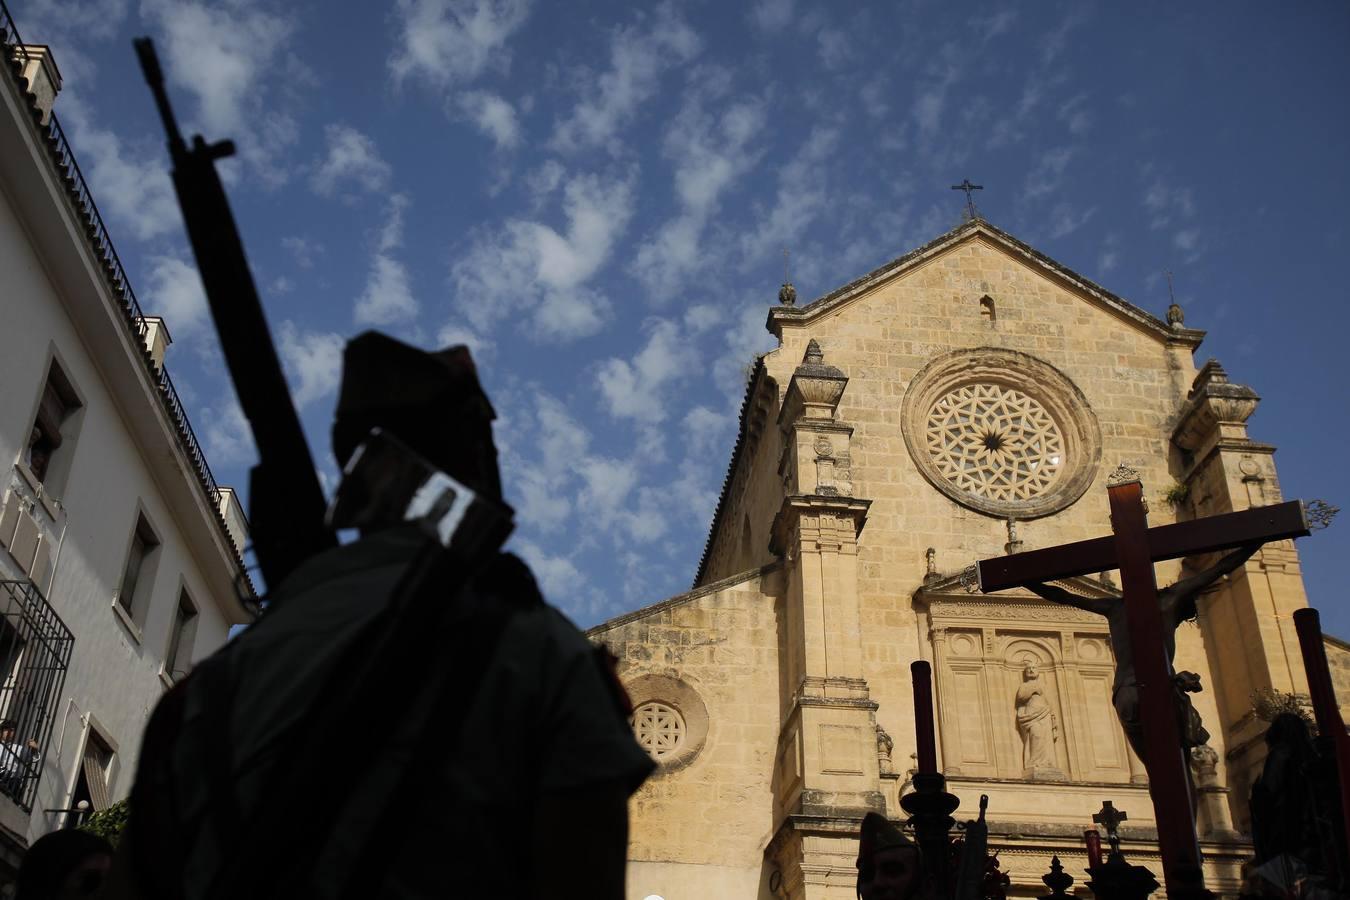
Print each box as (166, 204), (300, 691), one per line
(590, 567), (783, 900)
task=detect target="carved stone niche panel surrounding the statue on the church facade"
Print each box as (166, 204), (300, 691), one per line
(915, 578), (1131, 784)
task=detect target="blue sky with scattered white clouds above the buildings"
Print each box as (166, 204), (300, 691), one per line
(9, 0), (1350, 637)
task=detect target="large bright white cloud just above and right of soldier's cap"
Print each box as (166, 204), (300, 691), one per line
(451, 168), (635, 340)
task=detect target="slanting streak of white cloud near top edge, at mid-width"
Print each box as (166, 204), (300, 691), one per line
(551, 5), (702, 151)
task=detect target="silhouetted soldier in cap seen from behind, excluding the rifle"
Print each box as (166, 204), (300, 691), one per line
(112, 332), (653, 900)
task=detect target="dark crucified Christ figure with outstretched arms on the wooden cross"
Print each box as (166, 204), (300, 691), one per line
(1026, 544), (1261, 760)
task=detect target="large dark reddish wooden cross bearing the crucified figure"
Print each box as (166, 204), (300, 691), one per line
(976, 466), (1308, 900)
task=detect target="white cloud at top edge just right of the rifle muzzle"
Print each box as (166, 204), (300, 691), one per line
(140, 0), (300, 186)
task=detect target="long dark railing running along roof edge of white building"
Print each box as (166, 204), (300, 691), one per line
(0, 0), (251, 590)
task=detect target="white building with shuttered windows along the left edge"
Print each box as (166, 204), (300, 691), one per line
(0, 14), (251, 884)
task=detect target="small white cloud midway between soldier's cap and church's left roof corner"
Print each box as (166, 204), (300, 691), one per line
(595, 318), (698, 424)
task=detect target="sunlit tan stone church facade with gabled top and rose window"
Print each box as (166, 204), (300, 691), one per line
(591, 219), (1328, 900)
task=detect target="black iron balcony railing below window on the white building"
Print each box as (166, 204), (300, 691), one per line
(0, 582), (76, 812)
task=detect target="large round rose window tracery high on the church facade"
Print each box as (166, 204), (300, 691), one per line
(925, 383), (1065, 502)
